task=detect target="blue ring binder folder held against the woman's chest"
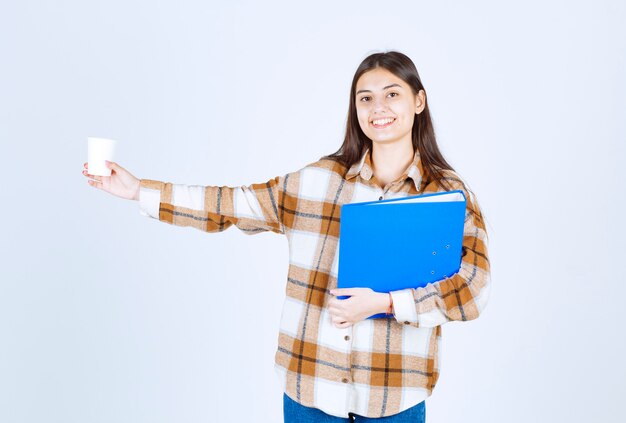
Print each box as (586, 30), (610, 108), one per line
(337, 190), (466, 318)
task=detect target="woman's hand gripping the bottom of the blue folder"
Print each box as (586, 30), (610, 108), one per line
(328, 288), (389, 328)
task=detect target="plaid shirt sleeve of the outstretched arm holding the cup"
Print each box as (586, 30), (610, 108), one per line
(139, 176), (287, 235)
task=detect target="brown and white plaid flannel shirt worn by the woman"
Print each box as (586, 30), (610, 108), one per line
(139, 150), (490, 417)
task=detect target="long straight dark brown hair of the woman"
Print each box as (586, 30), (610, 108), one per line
(323, 51), (454, 190)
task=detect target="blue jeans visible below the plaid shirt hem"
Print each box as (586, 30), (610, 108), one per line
(283, 394), (426, 423)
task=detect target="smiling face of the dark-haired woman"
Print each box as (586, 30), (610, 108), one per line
(355, 68), (426, 148)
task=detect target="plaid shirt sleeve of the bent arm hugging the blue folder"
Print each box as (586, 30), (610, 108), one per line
(391, 179), (491, 327)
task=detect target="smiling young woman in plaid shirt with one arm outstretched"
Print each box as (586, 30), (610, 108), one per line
(83, 51), (490, 422)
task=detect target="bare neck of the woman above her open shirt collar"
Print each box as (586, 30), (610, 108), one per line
(372, 138), (415, 187)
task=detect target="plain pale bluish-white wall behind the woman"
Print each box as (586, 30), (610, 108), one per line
(0, 0), (626, 423)
